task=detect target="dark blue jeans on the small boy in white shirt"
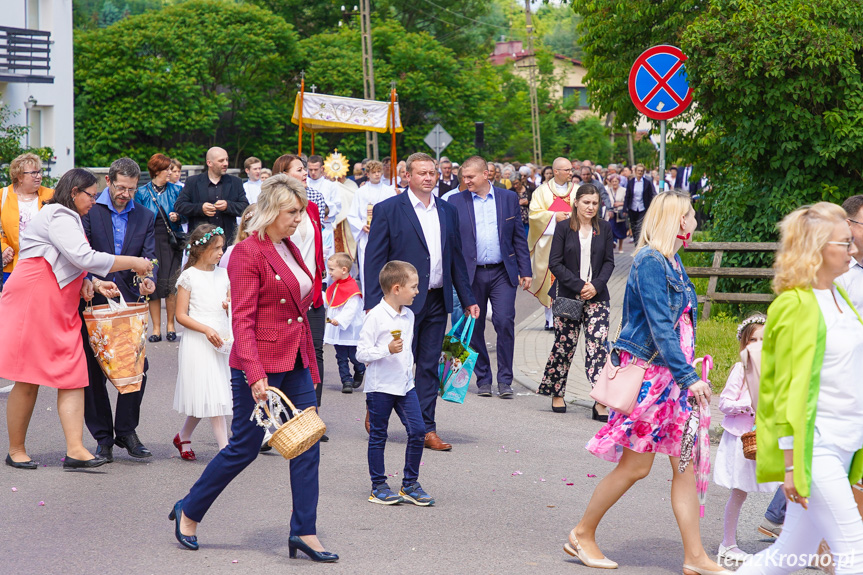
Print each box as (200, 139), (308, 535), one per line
(366, 388), (425, 489)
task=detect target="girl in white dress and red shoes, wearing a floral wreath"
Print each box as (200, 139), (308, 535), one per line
(174, 224), (233, 461)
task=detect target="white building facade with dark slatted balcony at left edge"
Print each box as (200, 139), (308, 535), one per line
(0, 0), (75, 177)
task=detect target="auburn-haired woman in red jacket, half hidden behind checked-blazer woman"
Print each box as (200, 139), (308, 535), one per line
(273, 154), (329, 414)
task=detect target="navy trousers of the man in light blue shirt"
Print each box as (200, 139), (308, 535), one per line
(470, 264), (516, 386)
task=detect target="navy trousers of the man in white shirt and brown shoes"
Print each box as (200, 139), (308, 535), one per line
(413, 289), (447, 433)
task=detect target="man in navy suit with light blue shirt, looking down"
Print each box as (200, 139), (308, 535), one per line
(449, 156), (533, 399)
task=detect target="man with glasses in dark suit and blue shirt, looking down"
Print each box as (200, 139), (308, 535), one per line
(81, 158), (158, 463)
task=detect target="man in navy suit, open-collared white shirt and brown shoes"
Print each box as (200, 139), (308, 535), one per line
(363, 154), (479, 451)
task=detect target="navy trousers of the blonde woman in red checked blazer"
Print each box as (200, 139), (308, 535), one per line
(183, 362), (321, 536)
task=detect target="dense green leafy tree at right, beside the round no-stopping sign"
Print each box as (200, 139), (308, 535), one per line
(681, 0), (863, 241)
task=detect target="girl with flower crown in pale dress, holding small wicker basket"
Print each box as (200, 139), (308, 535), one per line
(713, 313), (778, 562)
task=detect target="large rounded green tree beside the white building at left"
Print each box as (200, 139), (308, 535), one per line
(75, 0), (302, 169)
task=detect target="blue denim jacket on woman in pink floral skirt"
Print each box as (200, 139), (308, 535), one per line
(613, 247), (700, 389)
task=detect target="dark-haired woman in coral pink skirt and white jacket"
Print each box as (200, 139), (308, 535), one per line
(0, 168), (153, 469)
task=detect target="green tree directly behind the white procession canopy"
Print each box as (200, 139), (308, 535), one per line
(300, 20), (530, 162)
